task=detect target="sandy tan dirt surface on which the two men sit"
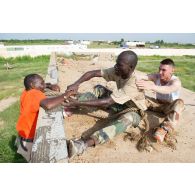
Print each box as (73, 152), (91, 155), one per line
(58, 56), (195, 163)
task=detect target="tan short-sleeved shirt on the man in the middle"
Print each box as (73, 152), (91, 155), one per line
(101, 68), (147, 110)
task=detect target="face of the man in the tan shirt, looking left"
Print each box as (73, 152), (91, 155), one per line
(114, 59), (134, 79)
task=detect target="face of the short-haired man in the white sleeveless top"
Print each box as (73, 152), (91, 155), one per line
(159, 64), (174, 81)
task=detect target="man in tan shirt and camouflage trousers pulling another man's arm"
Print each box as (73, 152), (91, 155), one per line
(65, 51), (147, 157)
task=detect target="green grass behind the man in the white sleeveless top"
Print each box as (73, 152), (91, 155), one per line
(137, 56), (195, 91)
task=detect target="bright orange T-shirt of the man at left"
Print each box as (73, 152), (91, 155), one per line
(16, 89), (46, 139)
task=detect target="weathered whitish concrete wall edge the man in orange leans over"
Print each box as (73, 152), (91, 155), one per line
(31, 53), (68, 163)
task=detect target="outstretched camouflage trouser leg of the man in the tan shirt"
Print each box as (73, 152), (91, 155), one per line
(90, 112), (141, 145)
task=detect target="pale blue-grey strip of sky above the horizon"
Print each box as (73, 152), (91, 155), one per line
(0, 33), (195, 43)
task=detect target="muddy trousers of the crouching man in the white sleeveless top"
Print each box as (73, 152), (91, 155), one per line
(146, 97), (184, 129)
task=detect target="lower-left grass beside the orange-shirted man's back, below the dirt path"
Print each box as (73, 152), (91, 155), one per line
(0, 101), (26, 163)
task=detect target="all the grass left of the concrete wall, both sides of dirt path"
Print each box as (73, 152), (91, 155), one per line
(0, 56), (49, 162)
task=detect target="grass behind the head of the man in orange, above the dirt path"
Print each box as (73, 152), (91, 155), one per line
(0, 56), (49, 100)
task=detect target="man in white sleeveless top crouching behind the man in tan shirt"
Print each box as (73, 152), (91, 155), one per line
(136, 59), (184, 142)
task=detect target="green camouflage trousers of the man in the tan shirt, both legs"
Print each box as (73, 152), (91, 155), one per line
(79, 85), (141, 144)
